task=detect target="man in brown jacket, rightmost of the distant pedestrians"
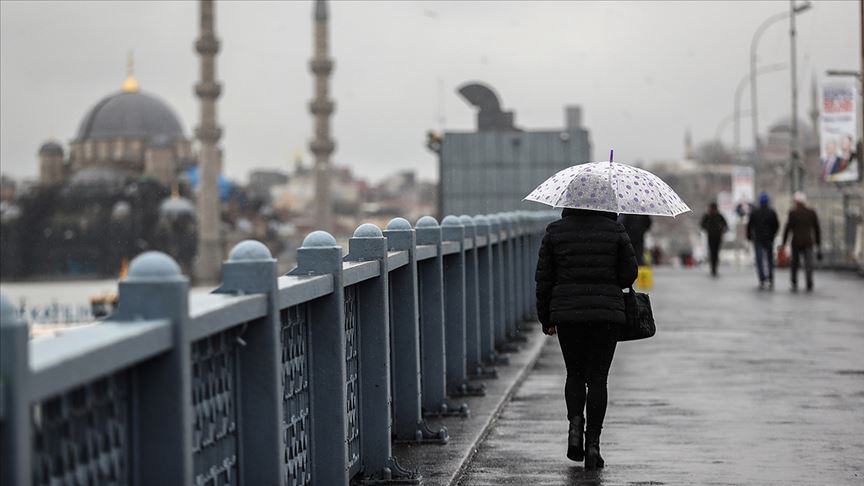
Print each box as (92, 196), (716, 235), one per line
(780, 191), (822, 292)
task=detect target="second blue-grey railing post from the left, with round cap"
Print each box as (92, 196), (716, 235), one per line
(111, 251), (193, 484)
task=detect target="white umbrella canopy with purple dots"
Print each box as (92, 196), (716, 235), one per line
(525, 162), (690, 216)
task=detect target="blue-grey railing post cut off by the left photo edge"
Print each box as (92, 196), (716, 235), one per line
(0, 295), (33, 485)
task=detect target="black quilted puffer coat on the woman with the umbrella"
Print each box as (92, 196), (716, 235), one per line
(534, 209), (637, 327)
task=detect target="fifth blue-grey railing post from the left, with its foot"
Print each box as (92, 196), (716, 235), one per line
(344, 224), (419, 481)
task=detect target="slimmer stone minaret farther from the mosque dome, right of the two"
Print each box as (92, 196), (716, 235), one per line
(309, 0), (336, 232)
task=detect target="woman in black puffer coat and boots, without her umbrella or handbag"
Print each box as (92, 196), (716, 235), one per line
(535, 209), (637, 469)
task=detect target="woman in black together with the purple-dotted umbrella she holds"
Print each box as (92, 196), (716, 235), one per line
(525, 153), (690, 469)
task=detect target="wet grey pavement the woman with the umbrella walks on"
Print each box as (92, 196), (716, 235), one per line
(457, 268), (864, 486)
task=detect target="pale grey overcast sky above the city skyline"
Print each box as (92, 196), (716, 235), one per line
(0, 1), (860, 180)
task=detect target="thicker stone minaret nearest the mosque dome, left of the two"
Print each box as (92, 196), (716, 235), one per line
(194, 0), (223, 283)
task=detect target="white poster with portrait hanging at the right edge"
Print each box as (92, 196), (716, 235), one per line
(819, 79), (861, 182)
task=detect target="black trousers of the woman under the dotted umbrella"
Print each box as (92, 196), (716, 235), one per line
(558, 323), (617, 436)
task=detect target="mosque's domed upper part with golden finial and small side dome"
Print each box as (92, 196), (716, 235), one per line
(39, 54), (197, 187)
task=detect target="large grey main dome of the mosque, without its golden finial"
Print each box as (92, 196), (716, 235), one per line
(77, 91), (184, 141)
